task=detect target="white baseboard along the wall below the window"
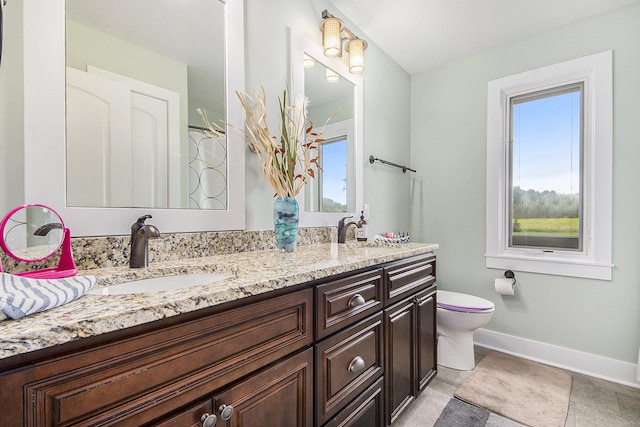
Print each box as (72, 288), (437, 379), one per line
(474, 329), (640, 388)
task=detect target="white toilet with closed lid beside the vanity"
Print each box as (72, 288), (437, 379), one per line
(436, 290), (495, 371)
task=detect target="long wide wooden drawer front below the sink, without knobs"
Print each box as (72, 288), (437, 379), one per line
(24, 289), (313, 426)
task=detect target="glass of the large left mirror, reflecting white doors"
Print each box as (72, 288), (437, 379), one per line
(66, 0), (227, 209)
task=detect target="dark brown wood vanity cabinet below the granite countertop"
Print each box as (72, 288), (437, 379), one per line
(0, 254), (436, 427)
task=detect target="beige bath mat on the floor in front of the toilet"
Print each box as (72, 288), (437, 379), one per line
(455, 351), (571, 427)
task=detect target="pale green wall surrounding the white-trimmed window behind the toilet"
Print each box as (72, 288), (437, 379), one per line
(411, 3), (640, 364)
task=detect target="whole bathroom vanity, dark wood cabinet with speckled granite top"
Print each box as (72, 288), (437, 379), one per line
(0, 244), (437, 426)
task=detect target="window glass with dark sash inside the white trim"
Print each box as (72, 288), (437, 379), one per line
(507, 82), (584, 250)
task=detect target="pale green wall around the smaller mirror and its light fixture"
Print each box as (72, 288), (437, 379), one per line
(245, 0), (410, 237)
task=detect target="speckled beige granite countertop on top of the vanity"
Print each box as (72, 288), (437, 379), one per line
(0, 243), (438, 359)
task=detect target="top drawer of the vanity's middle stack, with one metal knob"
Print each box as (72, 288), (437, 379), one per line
(316, 268), (382, 339)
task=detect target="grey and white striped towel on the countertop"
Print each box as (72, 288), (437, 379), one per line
(0, 274), (98, 320)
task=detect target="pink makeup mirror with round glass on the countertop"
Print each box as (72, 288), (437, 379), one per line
(0, 205), (78, 279)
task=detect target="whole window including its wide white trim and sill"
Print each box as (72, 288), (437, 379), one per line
(486, 51), (612, 280)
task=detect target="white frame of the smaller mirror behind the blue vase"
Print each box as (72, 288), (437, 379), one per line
(290, 29), (364, 227)
